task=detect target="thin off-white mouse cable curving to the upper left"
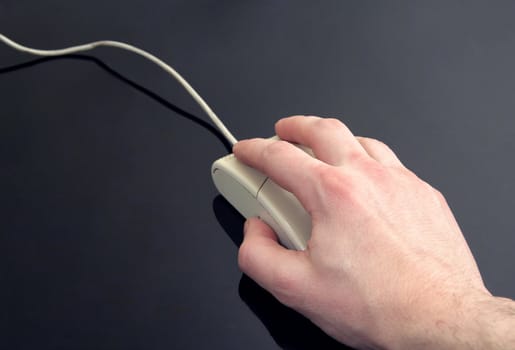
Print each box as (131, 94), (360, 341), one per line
(0, 34), (237, 145)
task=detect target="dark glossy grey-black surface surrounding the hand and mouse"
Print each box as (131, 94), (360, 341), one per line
(0, 0), (515, 349)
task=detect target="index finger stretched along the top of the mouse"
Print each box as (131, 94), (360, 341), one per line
(233, 138), (324, 213)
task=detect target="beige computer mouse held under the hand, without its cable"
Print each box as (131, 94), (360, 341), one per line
(211, 138), (311, 250)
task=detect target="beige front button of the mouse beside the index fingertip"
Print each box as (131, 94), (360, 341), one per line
(211, 154), (266, 197)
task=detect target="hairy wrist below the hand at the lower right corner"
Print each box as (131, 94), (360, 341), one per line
(381, 294), (515, 350)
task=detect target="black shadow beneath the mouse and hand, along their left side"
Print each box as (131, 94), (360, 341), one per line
(213, 195), (352, 350)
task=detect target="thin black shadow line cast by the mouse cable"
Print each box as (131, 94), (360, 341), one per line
(0, 55), (232, 153)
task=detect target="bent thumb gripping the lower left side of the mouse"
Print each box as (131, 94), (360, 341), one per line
(238, 218), (310, 307)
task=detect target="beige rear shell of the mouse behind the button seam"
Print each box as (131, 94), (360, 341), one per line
(258, 179), (311, 250)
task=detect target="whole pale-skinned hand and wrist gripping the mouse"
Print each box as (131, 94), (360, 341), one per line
(234, 116), (515, 349)
